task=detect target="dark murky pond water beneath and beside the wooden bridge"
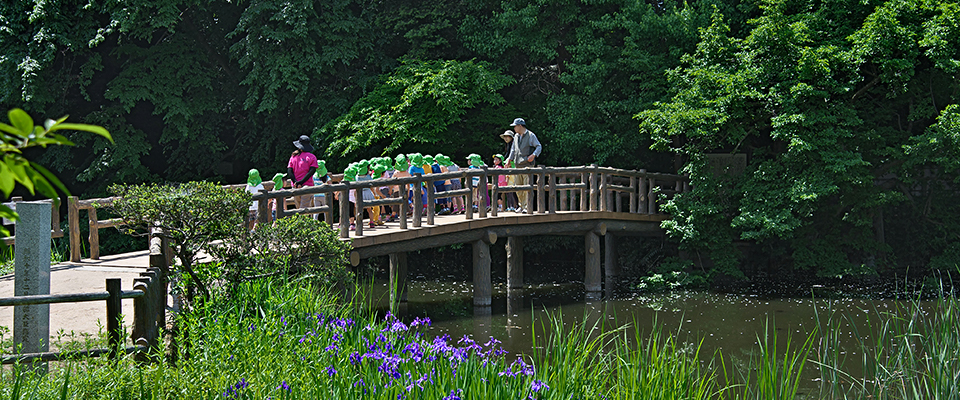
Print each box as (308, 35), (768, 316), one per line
(362, 280), (935, 390)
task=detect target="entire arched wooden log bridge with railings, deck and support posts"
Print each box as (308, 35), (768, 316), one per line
(68, 165), (689, 306)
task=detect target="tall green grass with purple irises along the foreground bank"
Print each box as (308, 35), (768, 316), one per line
(0, 279), (960, 400)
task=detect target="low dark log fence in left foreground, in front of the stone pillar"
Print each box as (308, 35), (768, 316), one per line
(0, 237), (170, 364)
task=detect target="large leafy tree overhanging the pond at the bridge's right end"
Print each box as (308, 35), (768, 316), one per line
(638, 0), (960, 276)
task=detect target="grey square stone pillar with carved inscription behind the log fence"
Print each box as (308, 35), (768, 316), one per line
(13, 201), (51, 364)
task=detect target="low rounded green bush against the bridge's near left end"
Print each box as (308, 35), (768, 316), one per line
(213, 215), (350, 284)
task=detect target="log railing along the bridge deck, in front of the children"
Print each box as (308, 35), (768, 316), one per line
(253, 165), (690, 238)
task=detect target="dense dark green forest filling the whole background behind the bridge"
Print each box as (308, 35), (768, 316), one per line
(0, 0), (960, 277)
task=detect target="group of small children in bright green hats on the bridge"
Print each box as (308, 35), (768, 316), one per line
(246, 153), (518, 229)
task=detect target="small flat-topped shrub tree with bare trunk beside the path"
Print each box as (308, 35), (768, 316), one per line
(110, 182), (251, 299)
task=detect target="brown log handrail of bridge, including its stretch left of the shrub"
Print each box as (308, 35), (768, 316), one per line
(60, 165), (690, 253)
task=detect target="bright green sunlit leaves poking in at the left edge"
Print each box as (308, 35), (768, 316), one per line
(0, 108), (112, 236)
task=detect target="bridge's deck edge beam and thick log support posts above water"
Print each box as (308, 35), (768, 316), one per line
(351, 212), (669, 307)
